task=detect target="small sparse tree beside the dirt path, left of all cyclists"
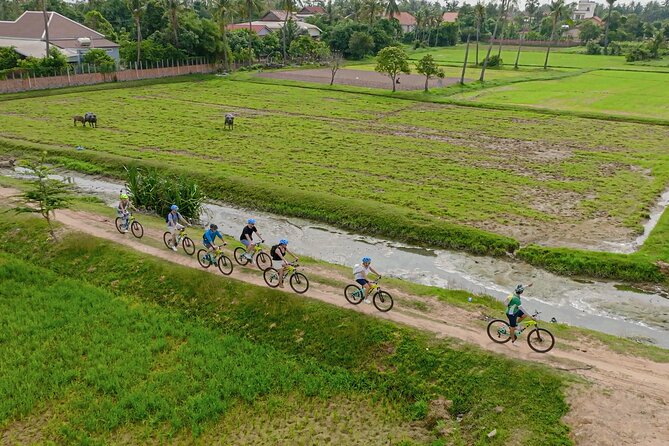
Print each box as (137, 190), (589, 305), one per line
(13, 152), (71, 240)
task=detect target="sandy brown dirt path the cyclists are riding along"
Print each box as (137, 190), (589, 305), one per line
(0, 188), (669, 446)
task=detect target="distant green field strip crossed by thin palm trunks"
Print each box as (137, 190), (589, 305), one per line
(410, 45), (669, 70)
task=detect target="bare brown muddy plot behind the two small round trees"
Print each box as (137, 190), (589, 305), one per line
(258, 68), (460, 91)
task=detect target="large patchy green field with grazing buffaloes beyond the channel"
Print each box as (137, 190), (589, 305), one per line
(0, 78), (669, 260)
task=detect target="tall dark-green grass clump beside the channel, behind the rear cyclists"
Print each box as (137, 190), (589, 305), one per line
(125, 167), (206, 218)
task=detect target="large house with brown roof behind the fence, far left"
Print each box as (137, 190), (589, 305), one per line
(0, 11), (119, 62)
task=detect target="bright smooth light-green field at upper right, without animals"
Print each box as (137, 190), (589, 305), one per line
(455, 71), (669, 120)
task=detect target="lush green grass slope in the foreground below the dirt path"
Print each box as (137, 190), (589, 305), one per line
(0, 216), (571, 445)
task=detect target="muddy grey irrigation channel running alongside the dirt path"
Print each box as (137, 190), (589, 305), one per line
(5, 168), (669, 348)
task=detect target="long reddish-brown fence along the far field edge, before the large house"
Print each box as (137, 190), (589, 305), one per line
(0, 59), (215, 93)
